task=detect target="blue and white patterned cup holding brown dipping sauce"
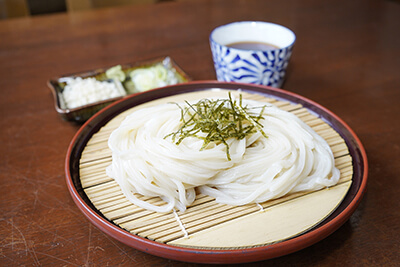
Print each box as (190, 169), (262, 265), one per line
(210, 21), (296, 87)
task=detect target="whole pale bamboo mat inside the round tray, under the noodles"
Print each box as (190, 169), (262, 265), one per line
(80, 90), (353, 249)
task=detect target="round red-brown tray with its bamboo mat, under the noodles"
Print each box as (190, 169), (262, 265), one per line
(65, 82), (367, 263)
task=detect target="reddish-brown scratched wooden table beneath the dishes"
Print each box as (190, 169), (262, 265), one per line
(0, 0), (400, 266)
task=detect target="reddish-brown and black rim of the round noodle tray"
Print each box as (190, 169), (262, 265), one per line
(65, 80), (368, 263)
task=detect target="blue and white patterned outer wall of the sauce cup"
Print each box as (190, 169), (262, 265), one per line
(210, 40), (293, 87)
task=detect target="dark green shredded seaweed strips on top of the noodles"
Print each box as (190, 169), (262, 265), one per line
(165, 93), (267, 160)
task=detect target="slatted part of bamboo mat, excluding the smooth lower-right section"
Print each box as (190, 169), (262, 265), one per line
(76, 94), (353, 247)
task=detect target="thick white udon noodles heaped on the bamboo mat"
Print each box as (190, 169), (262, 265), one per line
(107, 96), (340, 212)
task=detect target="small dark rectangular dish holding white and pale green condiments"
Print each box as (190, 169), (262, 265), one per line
(47, 57), (191, 123)
